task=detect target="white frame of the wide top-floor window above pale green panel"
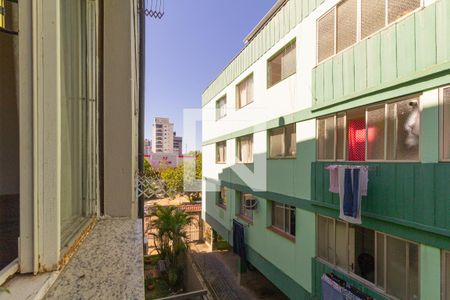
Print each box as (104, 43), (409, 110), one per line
(316, 0), (425, 65)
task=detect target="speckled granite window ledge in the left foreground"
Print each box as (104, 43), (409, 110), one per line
(46, 218), (145, 299)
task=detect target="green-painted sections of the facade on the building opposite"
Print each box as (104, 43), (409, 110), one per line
(203, 0), (450, 300)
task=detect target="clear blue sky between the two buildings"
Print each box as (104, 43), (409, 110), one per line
(145, 0), (276, 150)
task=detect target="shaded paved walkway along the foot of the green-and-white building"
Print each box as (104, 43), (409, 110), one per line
(192, 245), (287, 300)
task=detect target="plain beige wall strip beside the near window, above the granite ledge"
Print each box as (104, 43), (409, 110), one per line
(103, 0), (138, 218)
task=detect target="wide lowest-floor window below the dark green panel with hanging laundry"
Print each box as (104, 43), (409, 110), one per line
(317, 215), (420, 299)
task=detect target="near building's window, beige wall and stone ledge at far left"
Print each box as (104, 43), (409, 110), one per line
(0, 0), (144, 299)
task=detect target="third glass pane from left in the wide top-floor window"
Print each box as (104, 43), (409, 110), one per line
(361, 0), (386, 38)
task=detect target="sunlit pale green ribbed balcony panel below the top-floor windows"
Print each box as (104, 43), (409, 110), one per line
(312, 0), (450, 110)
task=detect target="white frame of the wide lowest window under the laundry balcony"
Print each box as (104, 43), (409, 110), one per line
(316, 214), (421, 298)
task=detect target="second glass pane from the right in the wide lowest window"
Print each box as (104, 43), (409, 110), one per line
(386, 236), (406, 299)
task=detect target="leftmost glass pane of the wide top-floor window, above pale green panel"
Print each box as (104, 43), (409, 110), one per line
(317, 9), (335, 62)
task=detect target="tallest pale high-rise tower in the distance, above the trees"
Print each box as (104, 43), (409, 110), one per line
(152, 117), (174, 153)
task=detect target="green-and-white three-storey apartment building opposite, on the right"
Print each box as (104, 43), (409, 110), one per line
(202, 0), (450, 300)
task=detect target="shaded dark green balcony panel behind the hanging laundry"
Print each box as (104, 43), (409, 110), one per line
(311, 162), (450, 236)
